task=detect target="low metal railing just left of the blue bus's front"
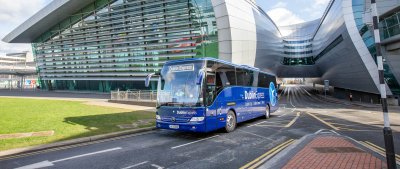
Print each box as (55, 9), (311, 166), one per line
(111, 90), (157, 102)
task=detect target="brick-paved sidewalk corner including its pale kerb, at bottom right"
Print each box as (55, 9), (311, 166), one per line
(259, 133), (387, 169)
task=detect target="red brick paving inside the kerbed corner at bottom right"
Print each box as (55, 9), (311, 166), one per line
(283, 136), (387, 169)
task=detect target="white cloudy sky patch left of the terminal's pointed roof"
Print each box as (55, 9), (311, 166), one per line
(0, 0), (51, 53)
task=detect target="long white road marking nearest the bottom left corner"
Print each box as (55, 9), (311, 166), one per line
(17, 147), (122, 169)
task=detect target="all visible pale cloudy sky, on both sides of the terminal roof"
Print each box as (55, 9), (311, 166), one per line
(0, 0), (330, 55)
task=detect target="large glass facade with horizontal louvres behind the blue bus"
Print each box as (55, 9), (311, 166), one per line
(32, 0), (218, 92)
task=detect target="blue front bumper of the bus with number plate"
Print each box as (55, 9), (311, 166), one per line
(156, 120), (207, 132)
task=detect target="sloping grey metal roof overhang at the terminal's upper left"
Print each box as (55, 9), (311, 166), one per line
(2, 0), (94, 43)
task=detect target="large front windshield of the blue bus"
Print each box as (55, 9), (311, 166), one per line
(157, 61), (204, 107)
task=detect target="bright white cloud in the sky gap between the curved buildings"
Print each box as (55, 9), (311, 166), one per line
(267, 8), (304, 26)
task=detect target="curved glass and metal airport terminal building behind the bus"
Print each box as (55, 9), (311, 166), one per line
(3, 0), (400, 98)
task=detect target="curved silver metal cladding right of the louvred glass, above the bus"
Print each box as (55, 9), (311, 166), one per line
(212, 0), (283, 74)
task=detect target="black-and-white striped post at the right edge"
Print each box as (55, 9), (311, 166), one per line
(371, 0), (397, 169)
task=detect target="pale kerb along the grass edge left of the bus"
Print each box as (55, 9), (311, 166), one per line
(0, 127), (156, 157)
